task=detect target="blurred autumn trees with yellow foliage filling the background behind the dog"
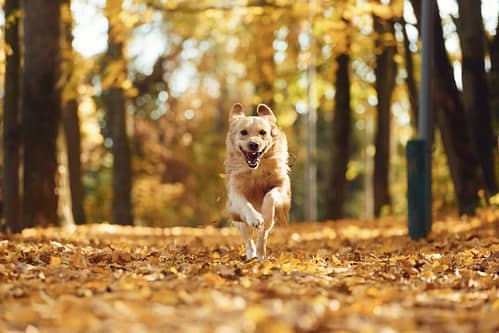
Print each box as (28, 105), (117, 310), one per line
(0, 0), (499, 231)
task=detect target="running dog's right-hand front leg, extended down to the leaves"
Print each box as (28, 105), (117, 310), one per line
(256, 187), (283, 258)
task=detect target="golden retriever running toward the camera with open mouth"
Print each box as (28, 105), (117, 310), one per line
(224, 103), (291, 260)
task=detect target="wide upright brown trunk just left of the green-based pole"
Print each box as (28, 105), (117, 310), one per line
(373, 16), (397, 216)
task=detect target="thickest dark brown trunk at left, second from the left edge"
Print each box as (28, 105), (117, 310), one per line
(22, 0), (61, 227)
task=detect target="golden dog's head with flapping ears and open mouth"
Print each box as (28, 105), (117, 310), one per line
(227, 103), (279, 169)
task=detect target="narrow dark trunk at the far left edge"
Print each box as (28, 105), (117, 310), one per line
(3, 0), (22, 232)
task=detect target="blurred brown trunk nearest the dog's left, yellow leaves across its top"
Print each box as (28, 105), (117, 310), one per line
(105, 0), (133, 225)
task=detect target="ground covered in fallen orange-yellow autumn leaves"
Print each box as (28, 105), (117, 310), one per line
(0, 210), (499, 333)
